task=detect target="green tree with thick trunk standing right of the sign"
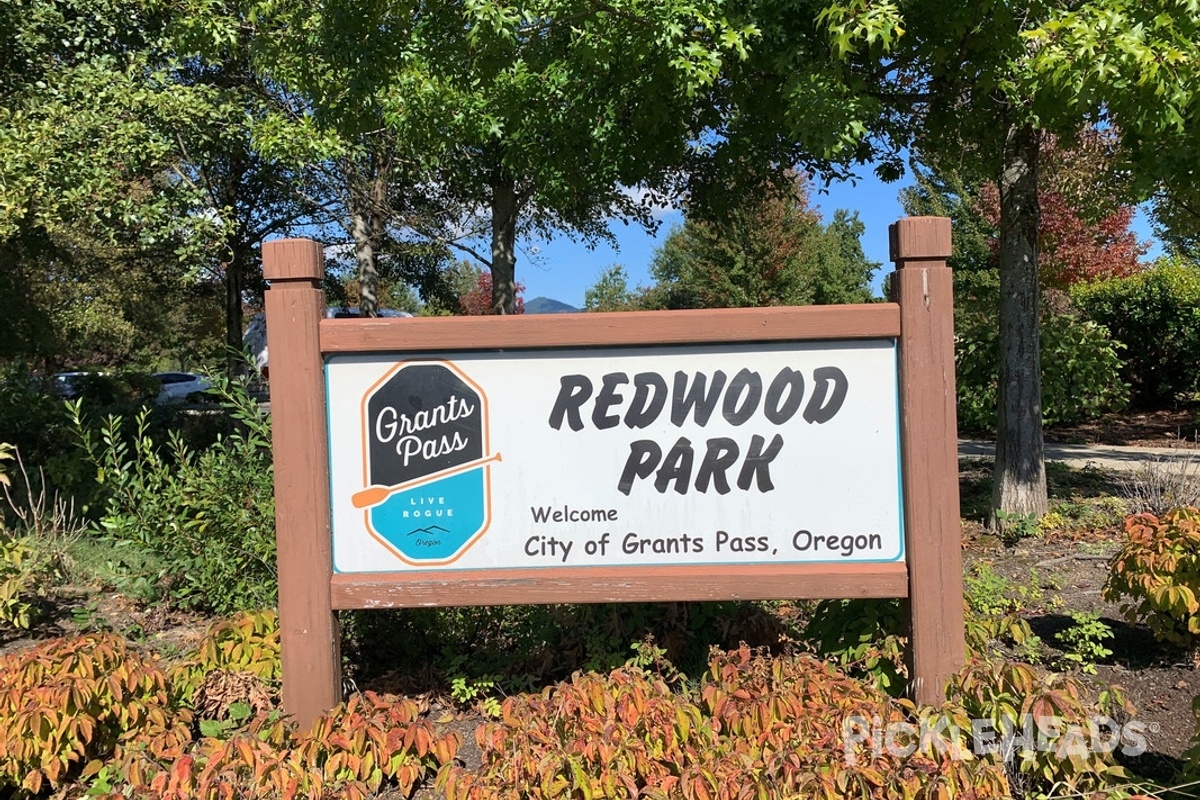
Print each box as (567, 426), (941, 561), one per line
(811, 0), (1200, 517)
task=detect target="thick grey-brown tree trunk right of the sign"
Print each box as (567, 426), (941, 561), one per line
(991, 126), (1046, 530)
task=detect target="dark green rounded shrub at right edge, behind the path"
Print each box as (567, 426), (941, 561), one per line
(1070, 260), (1200, 408)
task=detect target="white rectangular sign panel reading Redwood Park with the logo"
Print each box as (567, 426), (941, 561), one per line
(326, 339), (904, 572)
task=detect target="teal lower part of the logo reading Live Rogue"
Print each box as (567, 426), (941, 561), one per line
(370, 467), (487, 561)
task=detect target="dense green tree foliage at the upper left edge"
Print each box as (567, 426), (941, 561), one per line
(0, 0), (229, 368)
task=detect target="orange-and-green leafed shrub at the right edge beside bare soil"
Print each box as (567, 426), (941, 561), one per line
(1104, 506), (1200, 652)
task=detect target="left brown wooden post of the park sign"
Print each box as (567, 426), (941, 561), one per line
(263, 239), (342, 728)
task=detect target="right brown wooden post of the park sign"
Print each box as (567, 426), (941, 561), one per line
(889, 217), (966, 704)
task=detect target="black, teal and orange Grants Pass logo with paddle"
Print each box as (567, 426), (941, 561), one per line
(352, 361), (500, 565)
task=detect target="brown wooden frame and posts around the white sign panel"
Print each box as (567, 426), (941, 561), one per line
(263, 217), (965, 724)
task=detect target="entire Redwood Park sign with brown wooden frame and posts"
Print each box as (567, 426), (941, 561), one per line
(264, 217), (964, 722)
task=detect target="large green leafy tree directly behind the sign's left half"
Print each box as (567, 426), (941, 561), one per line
(220, 0), (752, 313)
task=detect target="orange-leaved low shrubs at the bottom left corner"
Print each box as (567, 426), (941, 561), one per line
(0, 614), (460, 800)
